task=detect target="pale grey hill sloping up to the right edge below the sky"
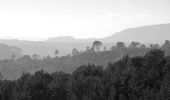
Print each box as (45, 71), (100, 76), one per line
(101, 24), (170, 43)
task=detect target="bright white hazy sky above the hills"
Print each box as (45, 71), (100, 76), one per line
(0, 0), (170, 40)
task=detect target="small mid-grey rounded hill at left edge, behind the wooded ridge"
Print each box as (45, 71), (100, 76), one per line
(0, 44), (22, 60)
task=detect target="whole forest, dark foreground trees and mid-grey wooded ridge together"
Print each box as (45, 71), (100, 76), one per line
(0, 40), (170, 100)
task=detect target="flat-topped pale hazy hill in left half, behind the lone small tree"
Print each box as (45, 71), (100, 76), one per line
(0, 40), (92, 57)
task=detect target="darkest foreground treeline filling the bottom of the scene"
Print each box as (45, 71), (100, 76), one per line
(0, 49), (170, 100)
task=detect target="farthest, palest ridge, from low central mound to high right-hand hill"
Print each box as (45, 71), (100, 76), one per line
(47, 24), (170, 43)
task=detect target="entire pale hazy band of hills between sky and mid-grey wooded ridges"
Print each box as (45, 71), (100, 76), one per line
(0, 24), (170, 56)
